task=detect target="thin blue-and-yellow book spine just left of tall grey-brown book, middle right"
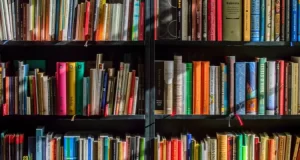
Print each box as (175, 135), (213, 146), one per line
(220, 63), (228, 115)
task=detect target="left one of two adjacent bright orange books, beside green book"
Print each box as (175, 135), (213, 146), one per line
(193, 61), (201, 114)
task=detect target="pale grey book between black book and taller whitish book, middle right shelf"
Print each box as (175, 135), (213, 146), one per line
(164, 61), (174, 114)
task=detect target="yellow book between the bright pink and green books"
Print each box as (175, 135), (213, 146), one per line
(67, 62), (76, 115)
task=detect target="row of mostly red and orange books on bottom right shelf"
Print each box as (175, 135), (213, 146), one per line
(154, 132), (300, 160)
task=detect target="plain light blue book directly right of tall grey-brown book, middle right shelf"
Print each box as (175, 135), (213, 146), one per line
(234, 62), (246, 115)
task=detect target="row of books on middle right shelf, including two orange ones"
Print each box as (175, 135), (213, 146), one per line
(155, 55), (300, 115)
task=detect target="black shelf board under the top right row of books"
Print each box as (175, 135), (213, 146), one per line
(155, 40), (300, 47)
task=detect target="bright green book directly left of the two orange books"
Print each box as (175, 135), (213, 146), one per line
(186, 63), (193, 115)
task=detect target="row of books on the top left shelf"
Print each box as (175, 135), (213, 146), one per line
(0, 0), (145, 41)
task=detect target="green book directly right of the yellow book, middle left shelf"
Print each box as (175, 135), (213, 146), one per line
(75, 62), (84, 115)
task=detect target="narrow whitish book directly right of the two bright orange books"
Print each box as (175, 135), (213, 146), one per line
(209, 66), (216, 115)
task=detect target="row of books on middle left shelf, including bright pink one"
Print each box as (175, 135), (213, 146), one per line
(0, 54), (144, 116)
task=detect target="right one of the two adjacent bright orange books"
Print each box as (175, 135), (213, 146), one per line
(201, 61), (210, 115)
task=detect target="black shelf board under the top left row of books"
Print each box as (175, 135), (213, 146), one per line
(0, 41), (145, 47)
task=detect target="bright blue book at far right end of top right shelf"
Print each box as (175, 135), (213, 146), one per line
(291, 0), (298, 42)
